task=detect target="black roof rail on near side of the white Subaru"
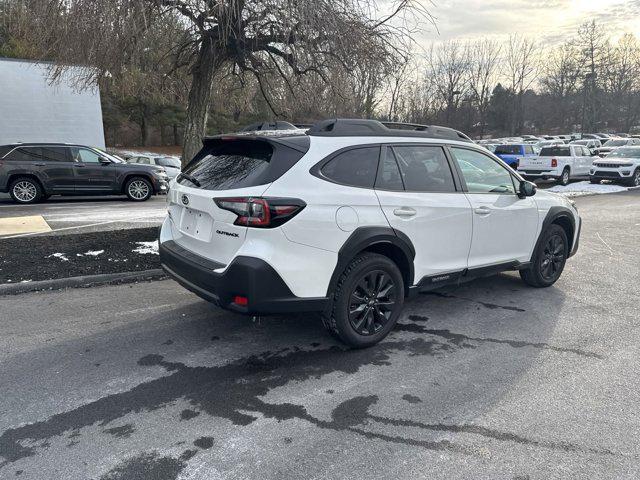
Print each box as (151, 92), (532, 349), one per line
(307, 118), (473, 142)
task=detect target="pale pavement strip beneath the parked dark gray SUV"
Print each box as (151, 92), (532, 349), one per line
(0, 194), (167, 235)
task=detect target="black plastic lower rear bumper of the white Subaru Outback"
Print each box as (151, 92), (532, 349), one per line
(159, 240), (329, 315)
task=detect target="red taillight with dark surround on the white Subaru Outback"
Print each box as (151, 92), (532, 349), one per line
(214, 197), (306, 228)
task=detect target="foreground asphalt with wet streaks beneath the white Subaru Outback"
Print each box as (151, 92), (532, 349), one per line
(0, 191), (640, 480)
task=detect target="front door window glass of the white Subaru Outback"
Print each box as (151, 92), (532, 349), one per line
(451, 147), (515, 193)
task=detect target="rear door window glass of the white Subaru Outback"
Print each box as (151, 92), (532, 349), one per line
(393, 145), (456, 192)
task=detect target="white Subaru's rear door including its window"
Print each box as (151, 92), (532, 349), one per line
(375, 144), (471, 284)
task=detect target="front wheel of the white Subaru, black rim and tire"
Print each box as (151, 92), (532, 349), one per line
(520, 224), (569, 288)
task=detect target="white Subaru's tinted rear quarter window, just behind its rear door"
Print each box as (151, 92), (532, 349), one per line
(320, 147), (380, 188)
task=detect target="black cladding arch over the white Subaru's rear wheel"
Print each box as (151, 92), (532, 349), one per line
(327, 227), (416, 296)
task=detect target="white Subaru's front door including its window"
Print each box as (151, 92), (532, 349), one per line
(450, 147), (538, 269)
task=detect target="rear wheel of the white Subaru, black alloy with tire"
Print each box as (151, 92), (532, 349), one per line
(323, 253), (404, 348)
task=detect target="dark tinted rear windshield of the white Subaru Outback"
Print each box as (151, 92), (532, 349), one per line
(178, 137), (308, 190)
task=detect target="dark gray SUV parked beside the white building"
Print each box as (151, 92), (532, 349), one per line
(0, 143), (169, 203)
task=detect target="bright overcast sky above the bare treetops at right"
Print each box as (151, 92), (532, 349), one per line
(420, 0), (640, 44)
